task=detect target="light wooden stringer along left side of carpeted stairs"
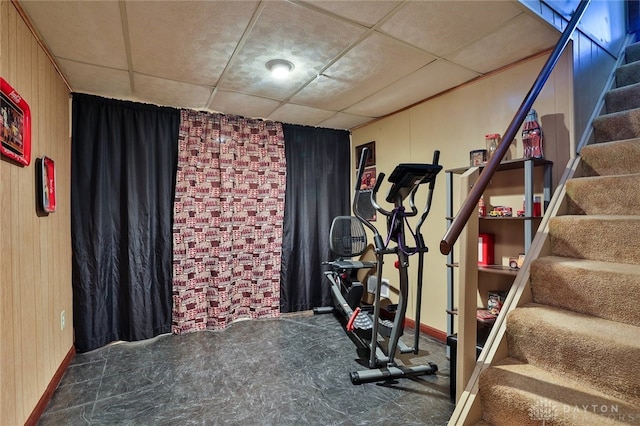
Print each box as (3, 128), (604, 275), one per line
(448, 157), (584, 426)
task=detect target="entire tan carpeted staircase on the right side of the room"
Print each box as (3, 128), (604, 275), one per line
(479, 43), (640, 426)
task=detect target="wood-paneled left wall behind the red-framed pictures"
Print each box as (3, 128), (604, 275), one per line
(0, 0), (73, 425)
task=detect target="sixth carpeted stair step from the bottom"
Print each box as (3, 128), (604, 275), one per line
(580, 138), (640, 176)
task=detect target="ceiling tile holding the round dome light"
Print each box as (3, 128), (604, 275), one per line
(218, 1), (365, 99)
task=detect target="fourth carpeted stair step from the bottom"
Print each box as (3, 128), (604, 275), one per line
(549, 215), (640, 265)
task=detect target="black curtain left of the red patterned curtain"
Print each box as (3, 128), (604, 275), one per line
(71, 94), (180, 352)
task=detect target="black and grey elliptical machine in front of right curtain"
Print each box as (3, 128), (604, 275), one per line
(314, 148), (442, 384)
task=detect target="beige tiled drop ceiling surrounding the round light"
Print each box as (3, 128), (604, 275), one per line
(14, 0), (559, 129)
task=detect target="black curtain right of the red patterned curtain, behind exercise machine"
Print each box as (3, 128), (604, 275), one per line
(280, 124), (355, 312)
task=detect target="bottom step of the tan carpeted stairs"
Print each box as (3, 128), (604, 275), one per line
(480, 358), (640, 426)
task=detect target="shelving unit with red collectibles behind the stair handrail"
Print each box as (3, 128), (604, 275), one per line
(445, 159), (552, 395)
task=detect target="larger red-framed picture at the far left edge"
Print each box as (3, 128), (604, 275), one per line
(0, 77), (31, 166)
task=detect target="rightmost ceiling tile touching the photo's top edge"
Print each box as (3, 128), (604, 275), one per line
(380, 1), (523, 56)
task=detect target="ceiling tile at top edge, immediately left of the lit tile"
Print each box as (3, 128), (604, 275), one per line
(126, 1), (257, 86)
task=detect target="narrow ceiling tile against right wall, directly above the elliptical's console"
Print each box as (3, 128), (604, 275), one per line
(344, 59), (480, 117)
